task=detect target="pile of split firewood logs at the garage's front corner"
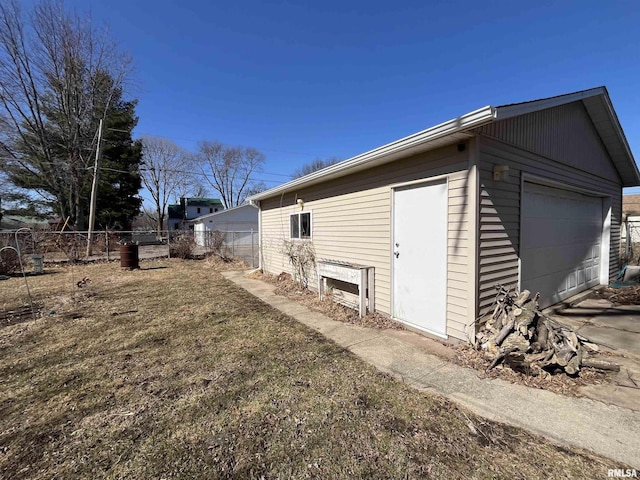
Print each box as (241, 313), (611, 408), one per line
(476, 285), (620, 375)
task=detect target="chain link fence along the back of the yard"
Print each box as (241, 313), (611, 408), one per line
(0, 228), (259, 274)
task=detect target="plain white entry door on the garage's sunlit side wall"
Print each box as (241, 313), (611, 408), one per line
(392, 181), (447, 336)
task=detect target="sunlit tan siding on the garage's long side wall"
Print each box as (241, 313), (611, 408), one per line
(261, 145), (473, 339)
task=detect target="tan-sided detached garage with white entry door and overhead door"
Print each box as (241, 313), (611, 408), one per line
(249, 87), (640, 340)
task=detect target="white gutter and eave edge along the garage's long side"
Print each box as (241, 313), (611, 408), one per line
(248, 106), (495, 201)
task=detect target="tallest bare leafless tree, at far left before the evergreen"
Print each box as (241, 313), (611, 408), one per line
(0, 0), (131, 226)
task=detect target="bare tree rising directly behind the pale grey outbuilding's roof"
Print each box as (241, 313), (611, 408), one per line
(198, 141), (265, 208)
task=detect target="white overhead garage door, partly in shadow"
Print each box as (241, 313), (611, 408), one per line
(520, 182), (602, 307)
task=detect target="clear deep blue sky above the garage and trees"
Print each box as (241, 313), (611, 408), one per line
(62, 0), (640, 193)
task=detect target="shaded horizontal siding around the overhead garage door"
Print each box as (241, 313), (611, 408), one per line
(478, 136), (621, 313)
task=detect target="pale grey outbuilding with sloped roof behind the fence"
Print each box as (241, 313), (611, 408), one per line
(191, 204), (258, 246)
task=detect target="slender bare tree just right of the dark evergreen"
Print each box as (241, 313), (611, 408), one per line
(141, 136), (193, 235)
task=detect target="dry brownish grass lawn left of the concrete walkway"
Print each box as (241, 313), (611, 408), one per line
(0, 260), (613, 479)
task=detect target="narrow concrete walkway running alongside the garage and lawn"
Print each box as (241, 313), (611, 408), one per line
(223, 271), (640, 469)
